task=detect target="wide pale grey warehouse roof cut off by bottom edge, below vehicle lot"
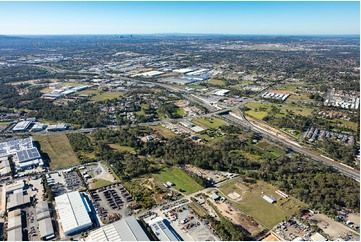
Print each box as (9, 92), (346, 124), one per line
(86, 216), (149, 241)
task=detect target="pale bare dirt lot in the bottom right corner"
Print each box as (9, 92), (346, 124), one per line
(309, 214), (360, 241)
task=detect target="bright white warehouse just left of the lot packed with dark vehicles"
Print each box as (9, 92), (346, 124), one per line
(55, 191), (92, 235)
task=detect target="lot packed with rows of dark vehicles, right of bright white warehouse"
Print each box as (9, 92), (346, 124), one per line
(90, 183), (133, 224)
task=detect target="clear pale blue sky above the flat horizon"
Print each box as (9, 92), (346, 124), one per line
(0, 2), (360, 34)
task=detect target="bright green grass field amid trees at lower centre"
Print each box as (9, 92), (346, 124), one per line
(153, 167), (203, 194)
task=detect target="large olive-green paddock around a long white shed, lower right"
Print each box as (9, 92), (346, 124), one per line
(220, 180), (306, 229)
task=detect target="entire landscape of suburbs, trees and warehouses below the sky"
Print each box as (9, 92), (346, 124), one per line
(0, 6), (360, 241)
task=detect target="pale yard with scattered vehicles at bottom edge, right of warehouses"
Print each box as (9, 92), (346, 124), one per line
(164, 205), (220, 241)
